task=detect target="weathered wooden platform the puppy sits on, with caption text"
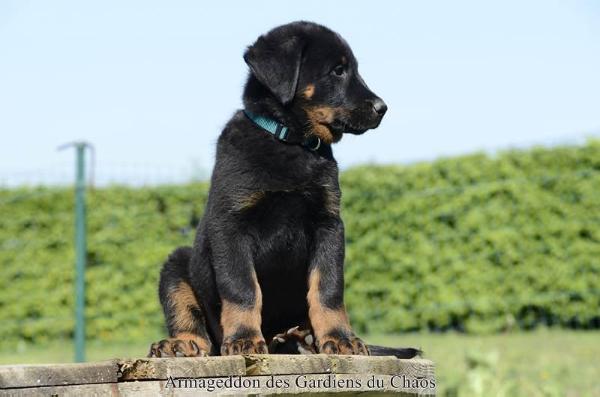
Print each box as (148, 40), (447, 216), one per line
(0, 354), (435, 396)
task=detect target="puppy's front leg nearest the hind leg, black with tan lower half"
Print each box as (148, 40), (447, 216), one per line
(213, 229), (268, 356)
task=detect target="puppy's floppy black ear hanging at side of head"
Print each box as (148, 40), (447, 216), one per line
(244, 36), (303, 105)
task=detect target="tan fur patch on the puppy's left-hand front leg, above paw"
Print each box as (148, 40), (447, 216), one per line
(221, 272), (262, 338)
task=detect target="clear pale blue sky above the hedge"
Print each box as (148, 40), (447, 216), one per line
(0, 0), (600, 183)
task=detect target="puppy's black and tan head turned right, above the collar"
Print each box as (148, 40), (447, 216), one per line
(244, 22), (387, 143)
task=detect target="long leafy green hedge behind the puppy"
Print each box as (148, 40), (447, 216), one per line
(0, 141), (600, 346)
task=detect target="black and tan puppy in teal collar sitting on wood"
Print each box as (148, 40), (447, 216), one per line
(150, 22), (416, 357)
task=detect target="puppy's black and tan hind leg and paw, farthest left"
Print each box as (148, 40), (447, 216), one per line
(148, 247), (212, 357)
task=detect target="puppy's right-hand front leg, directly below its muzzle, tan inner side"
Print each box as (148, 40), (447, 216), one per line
(307, 218), (369, 355)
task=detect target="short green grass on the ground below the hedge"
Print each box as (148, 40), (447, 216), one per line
(0, 329), (600, 397)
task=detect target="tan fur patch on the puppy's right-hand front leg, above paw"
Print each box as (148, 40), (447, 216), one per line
(307, 269), (351, 344)
